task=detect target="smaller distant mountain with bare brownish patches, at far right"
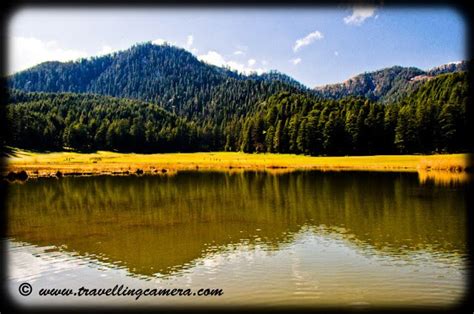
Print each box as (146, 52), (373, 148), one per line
(314, 61), (469, 103)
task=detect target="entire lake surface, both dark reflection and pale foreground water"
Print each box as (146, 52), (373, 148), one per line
(4, 171), (468, 308)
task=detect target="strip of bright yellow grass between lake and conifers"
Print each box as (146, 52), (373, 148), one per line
(5, 149), (469, 176)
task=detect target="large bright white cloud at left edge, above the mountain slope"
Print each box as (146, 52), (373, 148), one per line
(7, 36), (89, 74)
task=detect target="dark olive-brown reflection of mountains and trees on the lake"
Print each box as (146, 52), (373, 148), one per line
(8, 172), (466, 276)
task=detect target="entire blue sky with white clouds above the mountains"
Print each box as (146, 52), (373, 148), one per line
(7, 6), (468, 87)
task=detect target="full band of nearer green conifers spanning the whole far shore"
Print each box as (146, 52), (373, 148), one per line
(7, 73), (468, 155)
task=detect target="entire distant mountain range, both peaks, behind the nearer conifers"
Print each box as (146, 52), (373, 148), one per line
(8, 43), (469, 109)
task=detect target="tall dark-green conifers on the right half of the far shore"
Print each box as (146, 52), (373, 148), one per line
(240, 72), (468, 155)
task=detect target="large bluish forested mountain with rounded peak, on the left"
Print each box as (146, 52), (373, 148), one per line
(8, 43), (303, 118)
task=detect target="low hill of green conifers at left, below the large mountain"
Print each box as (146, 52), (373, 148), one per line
(7, 91), (199, 152)
